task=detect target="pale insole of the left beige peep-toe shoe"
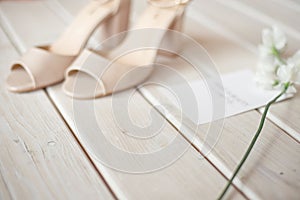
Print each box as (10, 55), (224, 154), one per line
(7, 0), (115, 92)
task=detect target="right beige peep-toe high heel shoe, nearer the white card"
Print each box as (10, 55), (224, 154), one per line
(63, 0), (190, 99)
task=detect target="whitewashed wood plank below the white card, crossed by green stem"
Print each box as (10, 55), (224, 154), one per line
(143, 82), (300, 199)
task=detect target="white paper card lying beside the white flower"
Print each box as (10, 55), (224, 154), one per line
(144, 70), (292, 124)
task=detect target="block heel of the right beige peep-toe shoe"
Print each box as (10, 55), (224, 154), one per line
(158, 11), (185, 57)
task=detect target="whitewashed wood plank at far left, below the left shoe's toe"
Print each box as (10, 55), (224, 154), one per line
(0, 10), (113, 199)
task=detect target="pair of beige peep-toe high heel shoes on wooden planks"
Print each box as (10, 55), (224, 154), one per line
(7, 0), (190, 99)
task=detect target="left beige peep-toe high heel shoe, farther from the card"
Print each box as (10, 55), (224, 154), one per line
(6, 0), (130, 92)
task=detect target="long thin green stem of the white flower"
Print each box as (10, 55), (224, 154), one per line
(218, 83), (290, 200)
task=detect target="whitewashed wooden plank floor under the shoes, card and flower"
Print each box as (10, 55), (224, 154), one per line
(0, 0), (300, 199)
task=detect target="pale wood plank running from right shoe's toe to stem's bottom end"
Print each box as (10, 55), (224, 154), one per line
(49, 86), (242, 199)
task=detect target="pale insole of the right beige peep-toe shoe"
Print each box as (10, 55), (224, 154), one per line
(64, 5), (183, 98)
